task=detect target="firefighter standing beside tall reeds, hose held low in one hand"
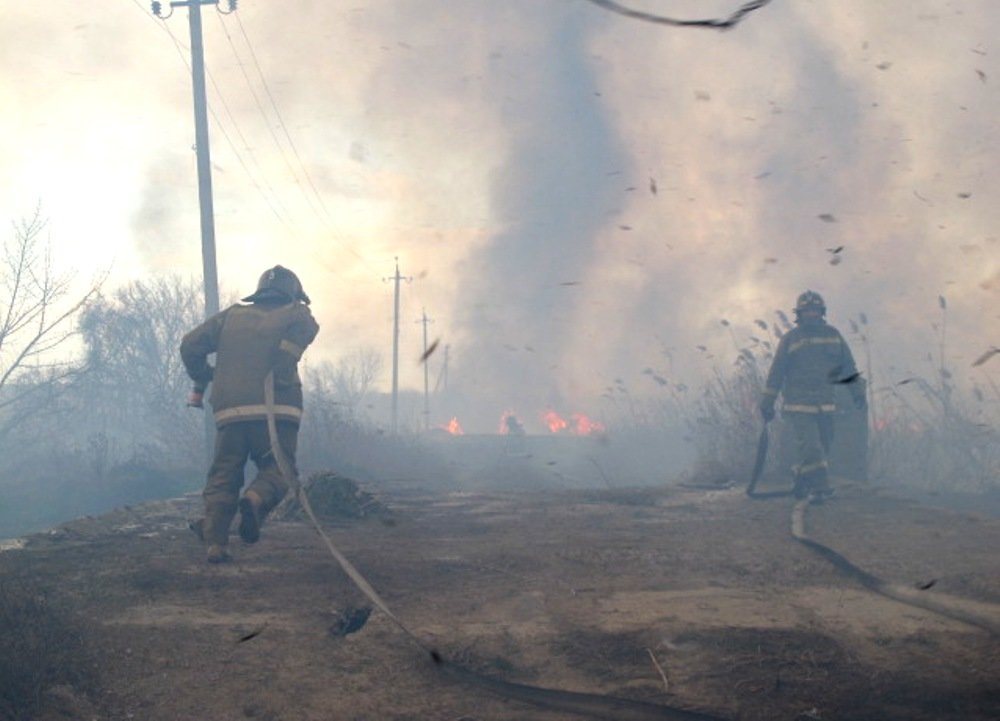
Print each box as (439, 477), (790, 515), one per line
(760, 290), (865, 502)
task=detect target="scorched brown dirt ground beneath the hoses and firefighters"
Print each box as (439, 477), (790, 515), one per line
(0, 483), (1000, 721)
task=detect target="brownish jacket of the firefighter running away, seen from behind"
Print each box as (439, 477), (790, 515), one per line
(181, 301), (319, 426)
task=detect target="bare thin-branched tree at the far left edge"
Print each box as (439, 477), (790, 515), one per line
(0, 208), (103, 437)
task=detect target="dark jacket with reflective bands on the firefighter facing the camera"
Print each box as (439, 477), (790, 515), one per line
(763, 319), (863, 413)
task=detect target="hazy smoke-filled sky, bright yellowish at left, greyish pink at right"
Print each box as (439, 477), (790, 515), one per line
(0, 0), (1000, 430)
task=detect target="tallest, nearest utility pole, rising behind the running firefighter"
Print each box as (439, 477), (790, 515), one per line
(152, 0), (228, 461)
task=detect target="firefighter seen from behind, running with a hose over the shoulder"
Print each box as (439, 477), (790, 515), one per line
(180, 265), (319, 563)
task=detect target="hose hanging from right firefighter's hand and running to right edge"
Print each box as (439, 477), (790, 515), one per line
(746, 422), (1000, 634)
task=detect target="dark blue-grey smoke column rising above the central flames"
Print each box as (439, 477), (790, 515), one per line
(455, 6), (630, 427)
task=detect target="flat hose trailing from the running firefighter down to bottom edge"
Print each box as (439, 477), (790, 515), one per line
(264, 371), (725, 721)
